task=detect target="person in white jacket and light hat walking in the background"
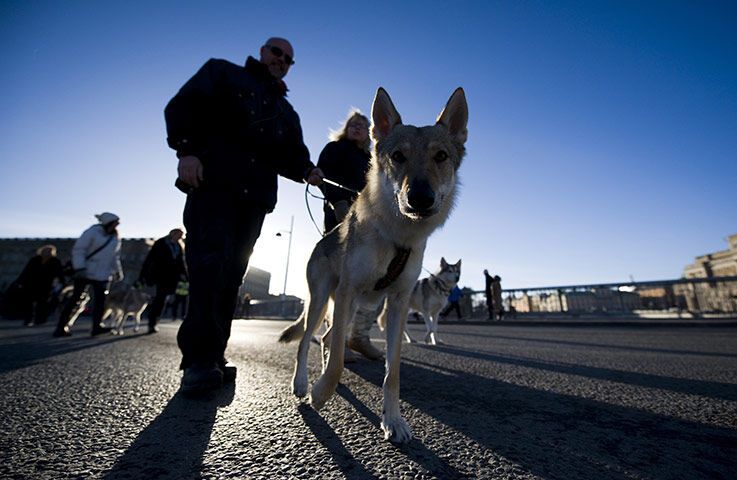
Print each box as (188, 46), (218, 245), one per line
(53, 212), (123, 337)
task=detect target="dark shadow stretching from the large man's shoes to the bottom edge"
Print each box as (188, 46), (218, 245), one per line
(105, 383), (235, 479)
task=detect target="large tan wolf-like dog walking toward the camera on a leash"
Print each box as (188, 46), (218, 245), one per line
(279, 88), (468, 442)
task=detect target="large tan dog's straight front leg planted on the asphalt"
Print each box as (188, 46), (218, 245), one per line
(381, 297), (412, 443)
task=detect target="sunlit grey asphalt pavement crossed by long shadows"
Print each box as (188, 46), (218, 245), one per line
(0, 320), (737, 480)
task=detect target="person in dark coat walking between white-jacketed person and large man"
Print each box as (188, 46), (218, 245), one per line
(138, 228), (187, 333)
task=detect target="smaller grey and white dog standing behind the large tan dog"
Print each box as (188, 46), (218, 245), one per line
(378, 258), (461, 345)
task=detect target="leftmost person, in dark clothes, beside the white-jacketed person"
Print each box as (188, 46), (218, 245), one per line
(16, 245), (64, 326)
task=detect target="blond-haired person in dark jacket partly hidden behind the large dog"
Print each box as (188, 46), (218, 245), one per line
(317, 109), (382, 360)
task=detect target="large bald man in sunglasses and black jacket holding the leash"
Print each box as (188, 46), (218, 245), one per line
(165, 38), (323, 395)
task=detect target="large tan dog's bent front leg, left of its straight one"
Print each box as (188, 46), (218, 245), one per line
(310, 291), (356, 410)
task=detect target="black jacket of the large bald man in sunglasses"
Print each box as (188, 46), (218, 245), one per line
(164, 57), (314, 211)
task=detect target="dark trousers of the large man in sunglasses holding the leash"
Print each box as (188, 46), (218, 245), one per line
(177, 187), (266, 368)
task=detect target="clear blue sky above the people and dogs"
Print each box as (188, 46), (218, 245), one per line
(0, 1), (737, 295)
